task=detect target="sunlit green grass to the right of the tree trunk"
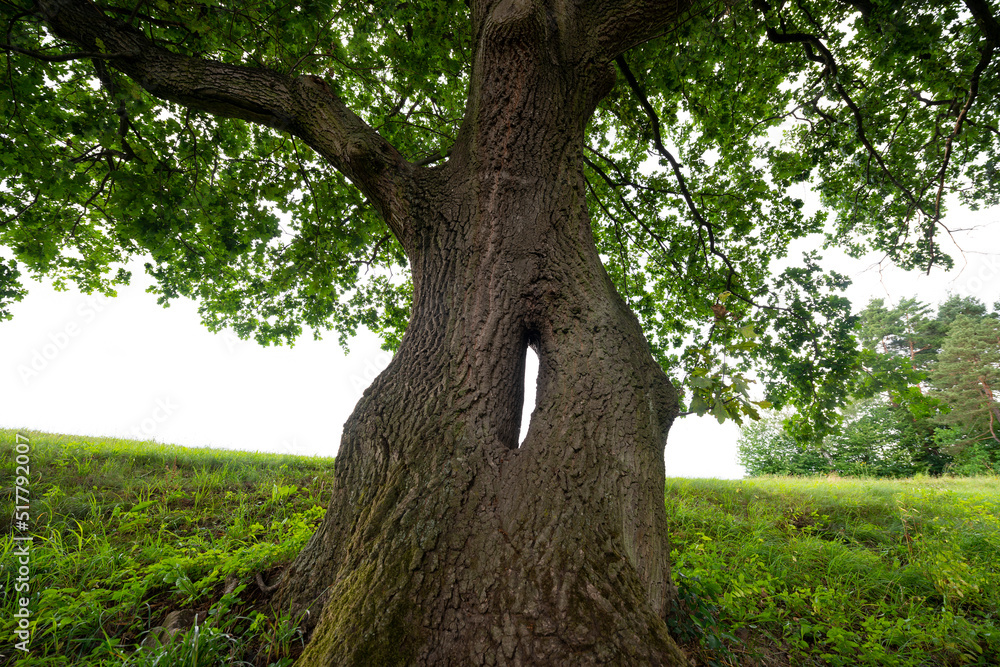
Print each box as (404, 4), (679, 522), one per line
(666, 477), (1000, 667)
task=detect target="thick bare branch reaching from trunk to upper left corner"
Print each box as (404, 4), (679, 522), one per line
(34, 0), (412, 247)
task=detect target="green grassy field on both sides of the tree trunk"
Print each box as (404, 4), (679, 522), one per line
(0, 430), (1000, 667)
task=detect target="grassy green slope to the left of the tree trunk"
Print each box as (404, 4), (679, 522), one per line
(0, 430), (333, 667)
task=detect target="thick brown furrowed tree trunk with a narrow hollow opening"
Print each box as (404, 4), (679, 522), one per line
(277, 3), (686, 666)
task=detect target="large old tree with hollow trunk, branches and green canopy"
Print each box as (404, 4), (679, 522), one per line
(0, 0), (1000, 665)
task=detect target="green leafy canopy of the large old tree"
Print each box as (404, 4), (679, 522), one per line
(0, 0), (1000, 428)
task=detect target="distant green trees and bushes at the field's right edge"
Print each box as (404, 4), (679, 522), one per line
(739, 296), (1000, 477)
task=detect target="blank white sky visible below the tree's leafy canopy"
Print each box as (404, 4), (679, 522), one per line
(0, 209), (1000, 478)
